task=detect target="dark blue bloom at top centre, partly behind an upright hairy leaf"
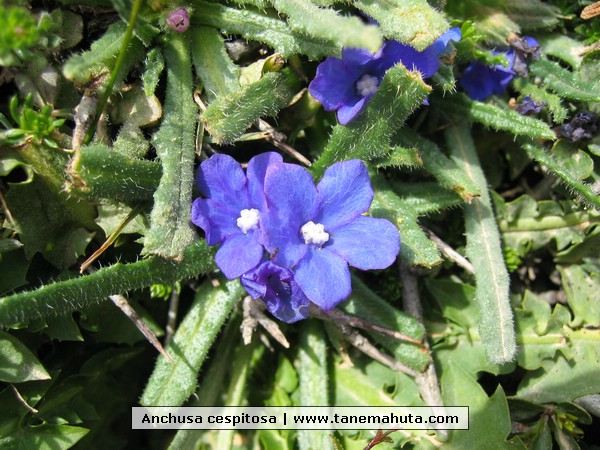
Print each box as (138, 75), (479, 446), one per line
(308, 28), (461, 125)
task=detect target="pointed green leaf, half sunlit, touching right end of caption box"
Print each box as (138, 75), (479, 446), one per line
(439, 365), (525, 450)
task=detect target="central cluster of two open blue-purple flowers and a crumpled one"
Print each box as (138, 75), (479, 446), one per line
(192, 152), (400, 323)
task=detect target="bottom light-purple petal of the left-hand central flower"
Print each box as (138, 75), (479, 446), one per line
(215, 232), (264, 280)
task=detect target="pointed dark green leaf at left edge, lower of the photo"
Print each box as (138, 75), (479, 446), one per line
(0, 331), (50, 383)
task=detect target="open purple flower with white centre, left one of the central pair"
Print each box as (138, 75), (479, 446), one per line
(192, 152), (282, 279)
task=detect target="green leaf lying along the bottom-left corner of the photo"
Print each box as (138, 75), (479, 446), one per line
(0, 423), (89, 450)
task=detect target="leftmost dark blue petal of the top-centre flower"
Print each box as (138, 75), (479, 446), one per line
(308, 58), (357, 111)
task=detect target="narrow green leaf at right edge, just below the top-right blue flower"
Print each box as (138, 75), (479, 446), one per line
(529, 59), (600, 102)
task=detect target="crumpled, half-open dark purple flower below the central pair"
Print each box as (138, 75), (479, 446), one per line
(240, 261), (310, 323)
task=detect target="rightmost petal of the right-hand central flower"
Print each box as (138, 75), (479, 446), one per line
(325, 216), (400, 270)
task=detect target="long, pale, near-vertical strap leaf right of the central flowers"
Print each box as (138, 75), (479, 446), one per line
(445, 125), (516, 364)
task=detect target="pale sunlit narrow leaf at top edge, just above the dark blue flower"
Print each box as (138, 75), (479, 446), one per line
(271, 0), (381, 52)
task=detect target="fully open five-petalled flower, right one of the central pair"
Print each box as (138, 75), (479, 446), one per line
(263, 160), (400, 310)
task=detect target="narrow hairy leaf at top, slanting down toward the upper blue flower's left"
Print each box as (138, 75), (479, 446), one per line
(192, 0), (342, 59)
